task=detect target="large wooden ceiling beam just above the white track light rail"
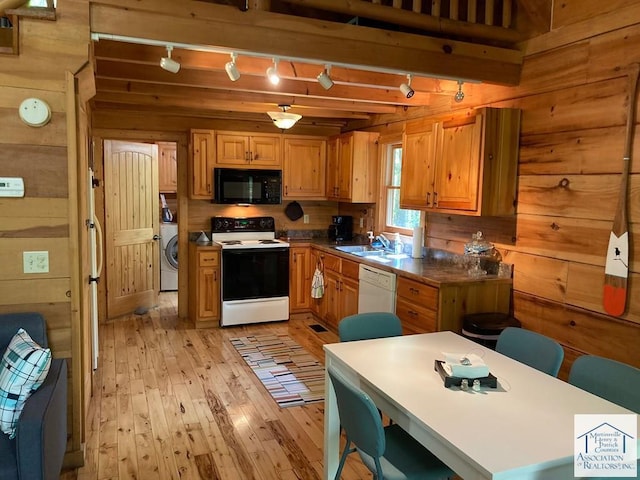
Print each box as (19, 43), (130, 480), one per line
(91, 0), (522, 85)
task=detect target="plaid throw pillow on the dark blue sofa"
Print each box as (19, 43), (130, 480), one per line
(0, 328), (51, 438)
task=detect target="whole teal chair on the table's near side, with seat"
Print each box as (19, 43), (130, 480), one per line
(328, 367), (454, 480)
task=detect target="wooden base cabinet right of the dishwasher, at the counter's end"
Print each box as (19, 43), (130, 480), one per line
(396, 276), (511, 334)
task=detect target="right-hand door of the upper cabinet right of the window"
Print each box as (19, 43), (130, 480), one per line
(433, 114), (482, 211)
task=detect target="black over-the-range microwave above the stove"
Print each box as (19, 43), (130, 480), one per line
(213, 168), (282, 205)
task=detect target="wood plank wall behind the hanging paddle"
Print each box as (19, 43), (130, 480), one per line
(398, 0), (640, 378)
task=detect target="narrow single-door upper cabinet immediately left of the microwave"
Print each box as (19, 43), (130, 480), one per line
(189, 130), (215, 200)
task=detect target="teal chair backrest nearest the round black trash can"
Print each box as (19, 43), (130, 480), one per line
(496, 327), (564, 377)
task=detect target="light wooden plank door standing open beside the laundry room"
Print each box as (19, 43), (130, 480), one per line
(104, 140), (160, 318)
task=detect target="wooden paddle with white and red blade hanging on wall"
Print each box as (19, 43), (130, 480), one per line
(603, 63), (640, 316)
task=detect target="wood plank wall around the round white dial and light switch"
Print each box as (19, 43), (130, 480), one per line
(0, 0), (89, 465)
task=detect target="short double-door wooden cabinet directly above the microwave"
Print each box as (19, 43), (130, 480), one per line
(216, 132), (282, 169)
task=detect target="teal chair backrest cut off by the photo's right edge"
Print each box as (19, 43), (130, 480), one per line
(569, 355), (640, 413)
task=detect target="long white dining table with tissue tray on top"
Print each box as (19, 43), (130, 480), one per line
(324, 332), (640, 480)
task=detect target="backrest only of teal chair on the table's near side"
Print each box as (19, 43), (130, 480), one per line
(327, 367), (386, 458)
